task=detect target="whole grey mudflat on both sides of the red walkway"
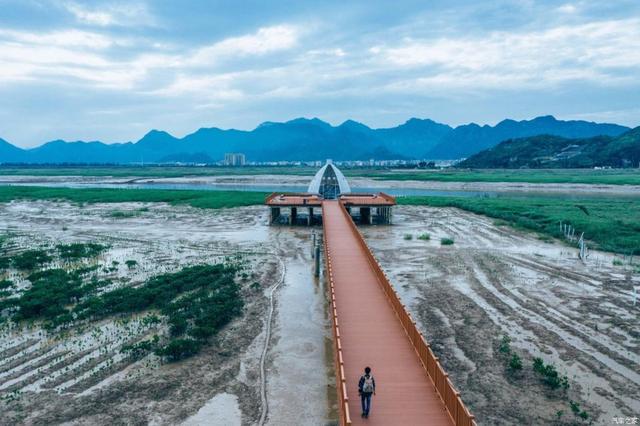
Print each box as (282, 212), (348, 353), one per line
(0, 202), (640, 425)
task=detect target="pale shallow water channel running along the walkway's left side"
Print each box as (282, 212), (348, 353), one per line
(267, 227), (329, 426)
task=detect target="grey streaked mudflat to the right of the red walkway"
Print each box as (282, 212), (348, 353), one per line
(361, 206), (640, 425)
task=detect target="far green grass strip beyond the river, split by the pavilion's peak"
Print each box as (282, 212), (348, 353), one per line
(0, 166), (640, 185)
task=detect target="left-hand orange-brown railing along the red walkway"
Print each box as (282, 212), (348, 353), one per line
(322, 228), (351, 426)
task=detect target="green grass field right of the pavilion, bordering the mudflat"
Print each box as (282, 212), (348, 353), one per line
(398, 197), (640, 254)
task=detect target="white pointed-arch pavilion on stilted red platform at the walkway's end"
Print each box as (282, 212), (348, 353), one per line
(266, 160), (396, 225)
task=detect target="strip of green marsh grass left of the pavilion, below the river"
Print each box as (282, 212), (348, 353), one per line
(0, 186), (268, 209)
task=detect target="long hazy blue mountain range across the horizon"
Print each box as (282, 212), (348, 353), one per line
(0, 116), (629, 164)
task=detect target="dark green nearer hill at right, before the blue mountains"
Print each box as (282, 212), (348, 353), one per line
(457, 127), (640, 169)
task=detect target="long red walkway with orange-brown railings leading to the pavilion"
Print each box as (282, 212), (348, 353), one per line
(322, 200), (475, 426)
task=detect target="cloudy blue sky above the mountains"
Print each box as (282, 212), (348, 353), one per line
(0, 0), (640, 147)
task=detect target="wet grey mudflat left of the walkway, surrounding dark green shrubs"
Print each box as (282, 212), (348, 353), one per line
(0, 202), (332, 425)
